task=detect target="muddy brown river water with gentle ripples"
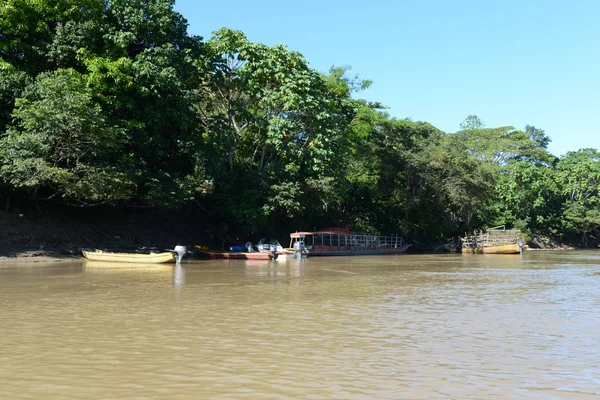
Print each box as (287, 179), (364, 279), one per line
(0, 252), (600, 399)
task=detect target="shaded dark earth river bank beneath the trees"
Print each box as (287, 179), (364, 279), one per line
(0, 208), (583, 263)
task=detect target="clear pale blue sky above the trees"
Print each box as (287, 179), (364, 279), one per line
(171, 0), (600, 155)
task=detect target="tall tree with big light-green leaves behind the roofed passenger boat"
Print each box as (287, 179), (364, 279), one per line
(198, 29), (354, 233)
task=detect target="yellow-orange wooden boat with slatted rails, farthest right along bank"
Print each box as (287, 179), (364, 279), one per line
(461, 225), (527, 254)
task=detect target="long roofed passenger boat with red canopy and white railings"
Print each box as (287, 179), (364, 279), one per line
(290, 228), (411, 257)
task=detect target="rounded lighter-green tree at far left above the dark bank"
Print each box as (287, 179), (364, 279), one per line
(0, 70), (134, 204)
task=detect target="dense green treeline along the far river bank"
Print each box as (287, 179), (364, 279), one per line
(0, 0), (600, 242)
